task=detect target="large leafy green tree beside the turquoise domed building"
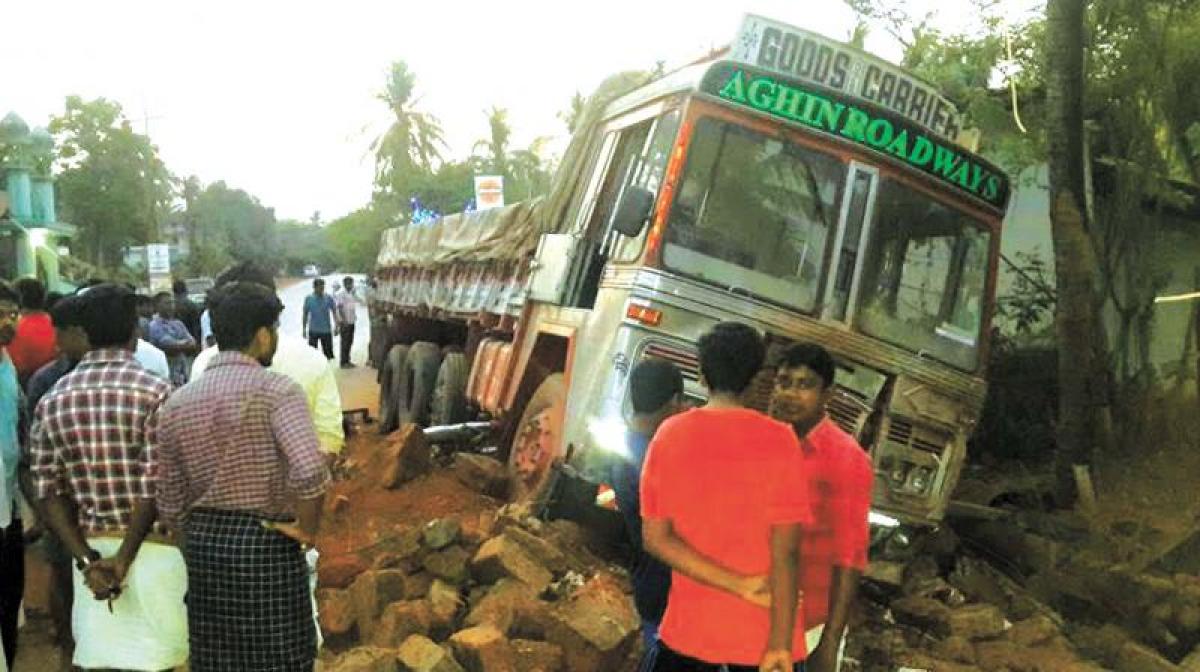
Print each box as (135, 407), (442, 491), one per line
(49, 96), (174, 266)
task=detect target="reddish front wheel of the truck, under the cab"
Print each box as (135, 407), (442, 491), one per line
(509, 373), (566, 502)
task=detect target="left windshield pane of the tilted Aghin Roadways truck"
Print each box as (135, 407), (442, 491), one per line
(662, 119), (846, 312)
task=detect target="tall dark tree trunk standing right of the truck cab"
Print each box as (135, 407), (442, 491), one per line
(1046, 0), (1108, 505)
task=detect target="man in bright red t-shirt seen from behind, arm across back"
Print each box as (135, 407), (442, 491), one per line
(641, 323), (811, 672)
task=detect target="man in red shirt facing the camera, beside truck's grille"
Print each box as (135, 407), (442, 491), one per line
(769, 343), (875, 672)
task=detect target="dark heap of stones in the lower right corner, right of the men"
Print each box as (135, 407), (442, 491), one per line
(848, 527), (1200, 672)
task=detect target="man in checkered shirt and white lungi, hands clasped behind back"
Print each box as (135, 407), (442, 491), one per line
(29, 284), (187, 671)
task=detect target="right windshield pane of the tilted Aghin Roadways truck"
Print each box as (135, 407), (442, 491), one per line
(854, 179), (991, 371)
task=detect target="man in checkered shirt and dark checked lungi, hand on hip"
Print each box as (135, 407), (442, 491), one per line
(158, 282), (329, 672)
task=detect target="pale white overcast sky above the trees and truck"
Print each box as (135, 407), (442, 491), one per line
(0, 0), (1028, 221)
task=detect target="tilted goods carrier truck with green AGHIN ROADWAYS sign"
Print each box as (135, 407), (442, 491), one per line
(372, 16), (1009, 542)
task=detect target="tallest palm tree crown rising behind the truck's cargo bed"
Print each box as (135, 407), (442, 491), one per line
(371, 61), (445, 192)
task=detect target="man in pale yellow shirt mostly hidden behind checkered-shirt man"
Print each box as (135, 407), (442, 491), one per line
(191, 262), (346, 457)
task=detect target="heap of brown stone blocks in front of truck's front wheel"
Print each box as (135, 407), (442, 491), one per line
(318, 430), (640, 672)
